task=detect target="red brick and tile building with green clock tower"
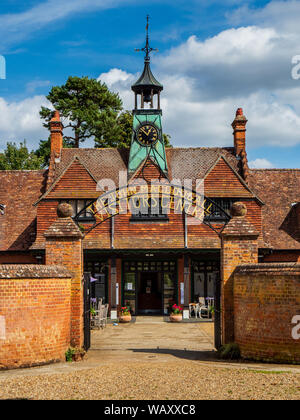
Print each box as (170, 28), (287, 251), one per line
(0, 40), (300, 314)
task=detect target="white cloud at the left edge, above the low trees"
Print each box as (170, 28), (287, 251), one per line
(0, 96), (49, 150)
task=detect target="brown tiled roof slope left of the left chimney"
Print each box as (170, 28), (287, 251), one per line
(0, 171), (47, 251)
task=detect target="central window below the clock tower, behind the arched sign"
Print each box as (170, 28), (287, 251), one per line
(130, 197), (169, 222)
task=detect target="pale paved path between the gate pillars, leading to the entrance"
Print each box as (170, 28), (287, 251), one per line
(88, 316), (214, 362)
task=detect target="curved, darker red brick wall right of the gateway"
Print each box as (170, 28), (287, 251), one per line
(234, 263), (300, 363)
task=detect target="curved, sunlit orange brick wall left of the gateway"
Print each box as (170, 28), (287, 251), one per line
(0, 265), (71, 369)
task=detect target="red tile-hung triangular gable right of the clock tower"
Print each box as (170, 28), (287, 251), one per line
(204, 157), (254, 198)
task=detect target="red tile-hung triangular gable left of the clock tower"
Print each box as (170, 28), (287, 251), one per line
(47, 159), (99, 199)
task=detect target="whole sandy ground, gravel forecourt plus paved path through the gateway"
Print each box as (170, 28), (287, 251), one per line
(0, 317), (300, 400)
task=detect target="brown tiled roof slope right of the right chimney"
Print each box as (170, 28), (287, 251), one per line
(249, 169), (300, 249)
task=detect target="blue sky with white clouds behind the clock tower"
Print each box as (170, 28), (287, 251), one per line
(0, 0), (300, 167)
